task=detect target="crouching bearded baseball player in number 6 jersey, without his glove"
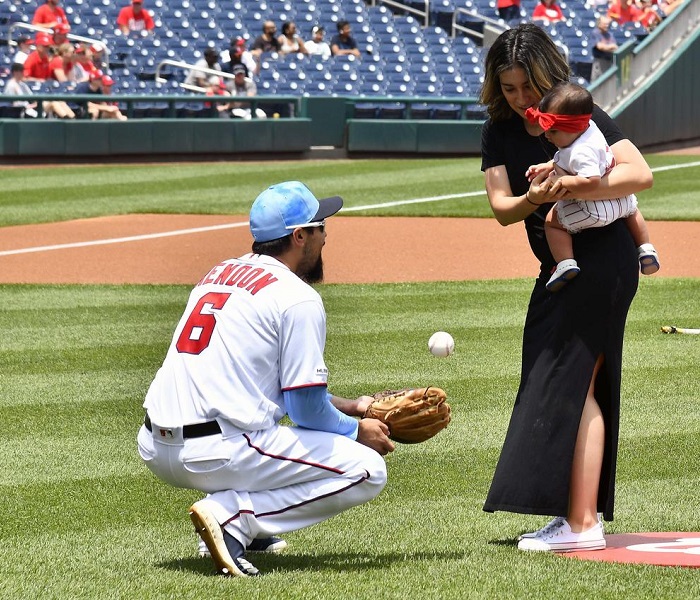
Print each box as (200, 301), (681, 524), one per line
(138, 181), (394, 577)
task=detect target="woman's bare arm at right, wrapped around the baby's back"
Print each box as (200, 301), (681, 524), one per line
(563, 140), (654, 200)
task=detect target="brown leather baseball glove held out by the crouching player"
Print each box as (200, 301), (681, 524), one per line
(364, 387), (451, 444)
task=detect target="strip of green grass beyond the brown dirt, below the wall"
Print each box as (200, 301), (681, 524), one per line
(0, 155), (700, 226)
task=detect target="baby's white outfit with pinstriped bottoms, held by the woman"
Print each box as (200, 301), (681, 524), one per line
(554, 121), (637, 233)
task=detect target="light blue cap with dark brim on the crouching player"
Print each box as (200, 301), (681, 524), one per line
(250, 181), (343, 242)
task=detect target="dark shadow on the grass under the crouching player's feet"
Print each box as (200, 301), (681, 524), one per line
(155, 552), (468, 575)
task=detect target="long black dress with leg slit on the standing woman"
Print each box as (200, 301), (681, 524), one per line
(481, 107), (639, 520)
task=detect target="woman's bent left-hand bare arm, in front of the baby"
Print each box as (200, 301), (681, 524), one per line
(484, 165), (566, 226)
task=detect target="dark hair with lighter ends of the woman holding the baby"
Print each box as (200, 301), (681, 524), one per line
(479, 23), (571, 121)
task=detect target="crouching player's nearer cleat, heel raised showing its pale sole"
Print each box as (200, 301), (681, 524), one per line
(190, 501), (260, 577)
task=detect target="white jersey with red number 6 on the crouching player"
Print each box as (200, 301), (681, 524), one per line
(144, 254), (328, 431)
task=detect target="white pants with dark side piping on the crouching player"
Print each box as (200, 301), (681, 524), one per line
(138, 424), (387, 547)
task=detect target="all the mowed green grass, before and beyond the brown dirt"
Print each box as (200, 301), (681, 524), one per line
(0, 156), (700, 600)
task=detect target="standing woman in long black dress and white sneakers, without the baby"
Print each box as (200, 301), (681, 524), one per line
(481, 24), (653, 551)
